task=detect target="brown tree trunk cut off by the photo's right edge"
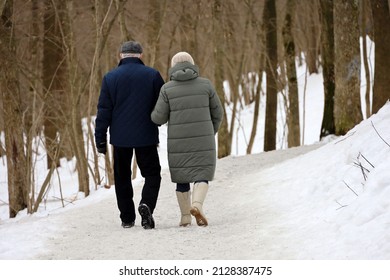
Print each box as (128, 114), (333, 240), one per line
(370, 0), (390, 114)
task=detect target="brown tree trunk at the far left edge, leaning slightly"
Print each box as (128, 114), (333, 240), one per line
(0, 0), (28, 218)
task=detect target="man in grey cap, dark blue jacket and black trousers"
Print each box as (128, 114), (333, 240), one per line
(95, 41), (164, 229)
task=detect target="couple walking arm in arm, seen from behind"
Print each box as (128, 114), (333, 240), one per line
(95, 41), (223, 229)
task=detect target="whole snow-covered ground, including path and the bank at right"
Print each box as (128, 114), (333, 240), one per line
(0, 104), (390, 260)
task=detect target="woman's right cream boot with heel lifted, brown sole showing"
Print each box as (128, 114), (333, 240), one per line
(190, 182), (209, 227)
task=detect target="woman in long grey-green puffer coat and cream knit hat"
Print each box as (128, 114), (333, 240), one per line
(151, 52), (223, 226)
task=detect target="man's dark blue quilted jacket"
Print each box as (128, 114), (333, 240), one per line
(95, 57), (164, 148)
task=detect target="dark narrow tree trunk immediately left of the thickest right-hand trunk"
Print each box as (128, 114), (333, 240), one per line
(320, 0), (336, 138)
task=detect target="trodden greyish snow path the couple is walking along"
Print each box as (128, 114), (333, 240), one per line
(32, 145), (321, 260)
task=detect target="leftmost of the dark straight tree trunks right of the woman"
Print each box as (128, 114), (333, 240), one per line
(264, 0), (278, 151)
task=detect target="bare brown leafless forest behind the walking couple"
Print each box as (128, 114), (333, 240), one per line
(0, 0), (390, 218)
